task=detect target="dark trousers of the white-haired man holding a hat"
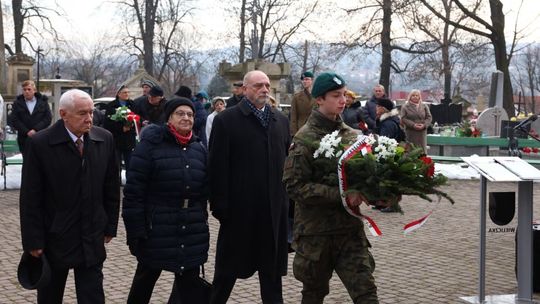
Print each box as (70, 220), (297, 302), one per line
(37, 264), (105, 304)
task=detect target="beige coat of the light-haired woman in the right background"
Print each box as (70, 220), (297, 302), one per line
(401, 102), (432, 151)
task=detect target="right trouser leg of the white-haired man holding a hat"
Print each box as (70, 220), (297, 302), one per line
(74, 263), (105, 304)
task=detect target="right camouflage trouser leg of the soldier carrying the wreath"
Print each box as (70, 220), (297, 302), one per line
(335, 235), (379, 304)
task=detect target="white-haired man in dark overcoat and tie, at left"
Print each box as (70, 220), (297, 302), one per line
(20, 90), (120, 303)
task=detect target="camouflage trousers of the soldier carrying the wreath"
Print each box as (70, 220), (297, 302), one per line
(293, 234), (379, 304)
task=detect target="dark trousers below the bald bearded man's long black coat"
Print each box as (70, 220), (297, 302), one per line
(210, 273), (283, 304)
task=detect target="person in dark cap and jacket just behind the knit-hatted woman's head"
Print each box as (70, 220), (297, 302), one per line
(133, 85), (167, 127)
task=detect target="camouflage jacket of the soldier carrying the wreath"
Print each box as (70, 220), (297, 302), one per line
(283, 110), (364, 239)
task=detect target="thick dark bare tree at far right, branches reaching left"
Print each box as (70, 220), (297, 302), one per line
(419, 0), (518, 116)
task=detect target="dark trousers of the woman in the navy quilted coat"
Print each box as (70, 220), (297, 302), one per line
(127, 263), (201, 304)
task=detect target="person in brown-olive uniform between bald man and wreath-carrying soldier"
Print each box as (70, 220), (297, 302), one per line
(290, 71), (315, 136)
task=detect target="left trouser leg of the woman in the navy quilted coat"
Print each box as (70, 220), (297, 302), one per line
(127, 263), (161, 304)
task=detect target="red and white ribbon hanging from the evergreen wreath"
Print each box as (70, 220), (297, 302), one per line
(337, 136), (440, 236)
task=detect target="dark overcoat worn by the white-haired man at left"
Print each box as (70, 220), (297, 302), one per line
(20, 120), (120, 267)
